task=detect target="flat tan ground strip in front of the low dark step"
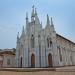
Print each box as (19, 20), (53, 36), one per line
(0, 71), (75, 75)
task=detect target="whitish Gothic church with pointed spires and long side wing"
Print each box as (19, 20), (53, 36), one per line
(15, 7), (75, 68)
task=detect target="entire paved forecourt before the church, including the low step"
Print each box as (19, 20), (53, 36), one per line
(0, 66), (75, 75)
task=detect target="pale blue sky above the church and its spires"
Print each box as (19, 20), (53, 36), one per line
(0, 0), (75, 49)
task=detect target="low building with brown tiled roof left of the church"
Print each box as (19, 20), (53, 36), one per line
(0, 49), (15, 68)
